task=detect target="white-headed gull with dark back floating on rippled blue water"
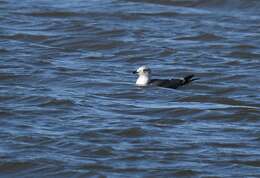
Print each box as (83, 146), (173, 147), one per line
(133, 65), (198, 89)
